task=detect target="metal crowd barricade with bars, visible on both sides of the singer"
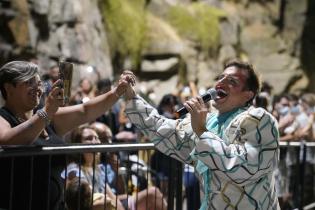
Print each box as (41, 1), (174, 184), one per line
(0, 141), (315, 210)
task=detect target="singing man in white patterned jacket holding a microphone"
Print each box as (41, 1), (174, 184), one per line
(125, 61), (280, 210)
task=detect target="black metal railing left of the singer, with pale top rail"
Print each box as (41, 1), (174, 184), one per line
(0, 143), (183, 210)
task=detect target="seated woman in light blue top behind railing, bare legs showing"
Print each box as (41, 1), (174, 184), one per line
(67, 126), (167, 210)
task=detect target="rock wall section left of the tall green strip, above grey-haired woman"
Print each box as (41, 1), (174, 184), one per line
(0, 0), (113, 82)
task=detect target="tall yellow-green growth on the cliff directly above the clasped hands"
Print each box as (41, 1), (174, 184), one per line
(100, 0), (147, 67)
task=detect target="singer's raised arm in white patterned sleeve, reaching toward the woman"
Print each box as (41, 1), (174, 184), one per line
(126, 96), (197, 163)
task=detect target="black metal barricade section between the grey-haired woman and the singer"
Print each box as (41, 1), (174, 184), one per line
(0, 143), (182, 210)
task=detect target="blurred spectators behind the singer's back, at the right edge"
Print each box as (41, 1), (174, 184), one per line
(270, 93), (315, 209)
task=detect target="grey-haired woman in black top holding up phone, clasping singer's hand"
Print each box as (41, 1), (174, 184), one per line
(0, 61), (134, 210)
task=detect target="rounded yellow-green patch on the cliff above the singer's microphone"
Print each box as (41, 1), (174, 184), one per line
(168, 2), (225, 51)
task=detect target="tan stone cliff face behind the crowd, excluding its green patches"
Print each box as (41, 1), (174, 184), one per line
(0, 0), (315, 103)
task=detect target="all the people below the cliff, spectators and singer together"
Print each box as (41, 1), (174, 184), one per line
(0, 61), (315, 210)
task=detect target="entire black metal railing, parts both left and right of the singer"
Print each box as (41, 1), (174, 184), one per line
(0, 141), (315, 210)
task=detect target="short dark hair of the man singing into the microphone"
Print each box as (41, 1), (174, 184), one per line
(224, 60), (260, 104)
